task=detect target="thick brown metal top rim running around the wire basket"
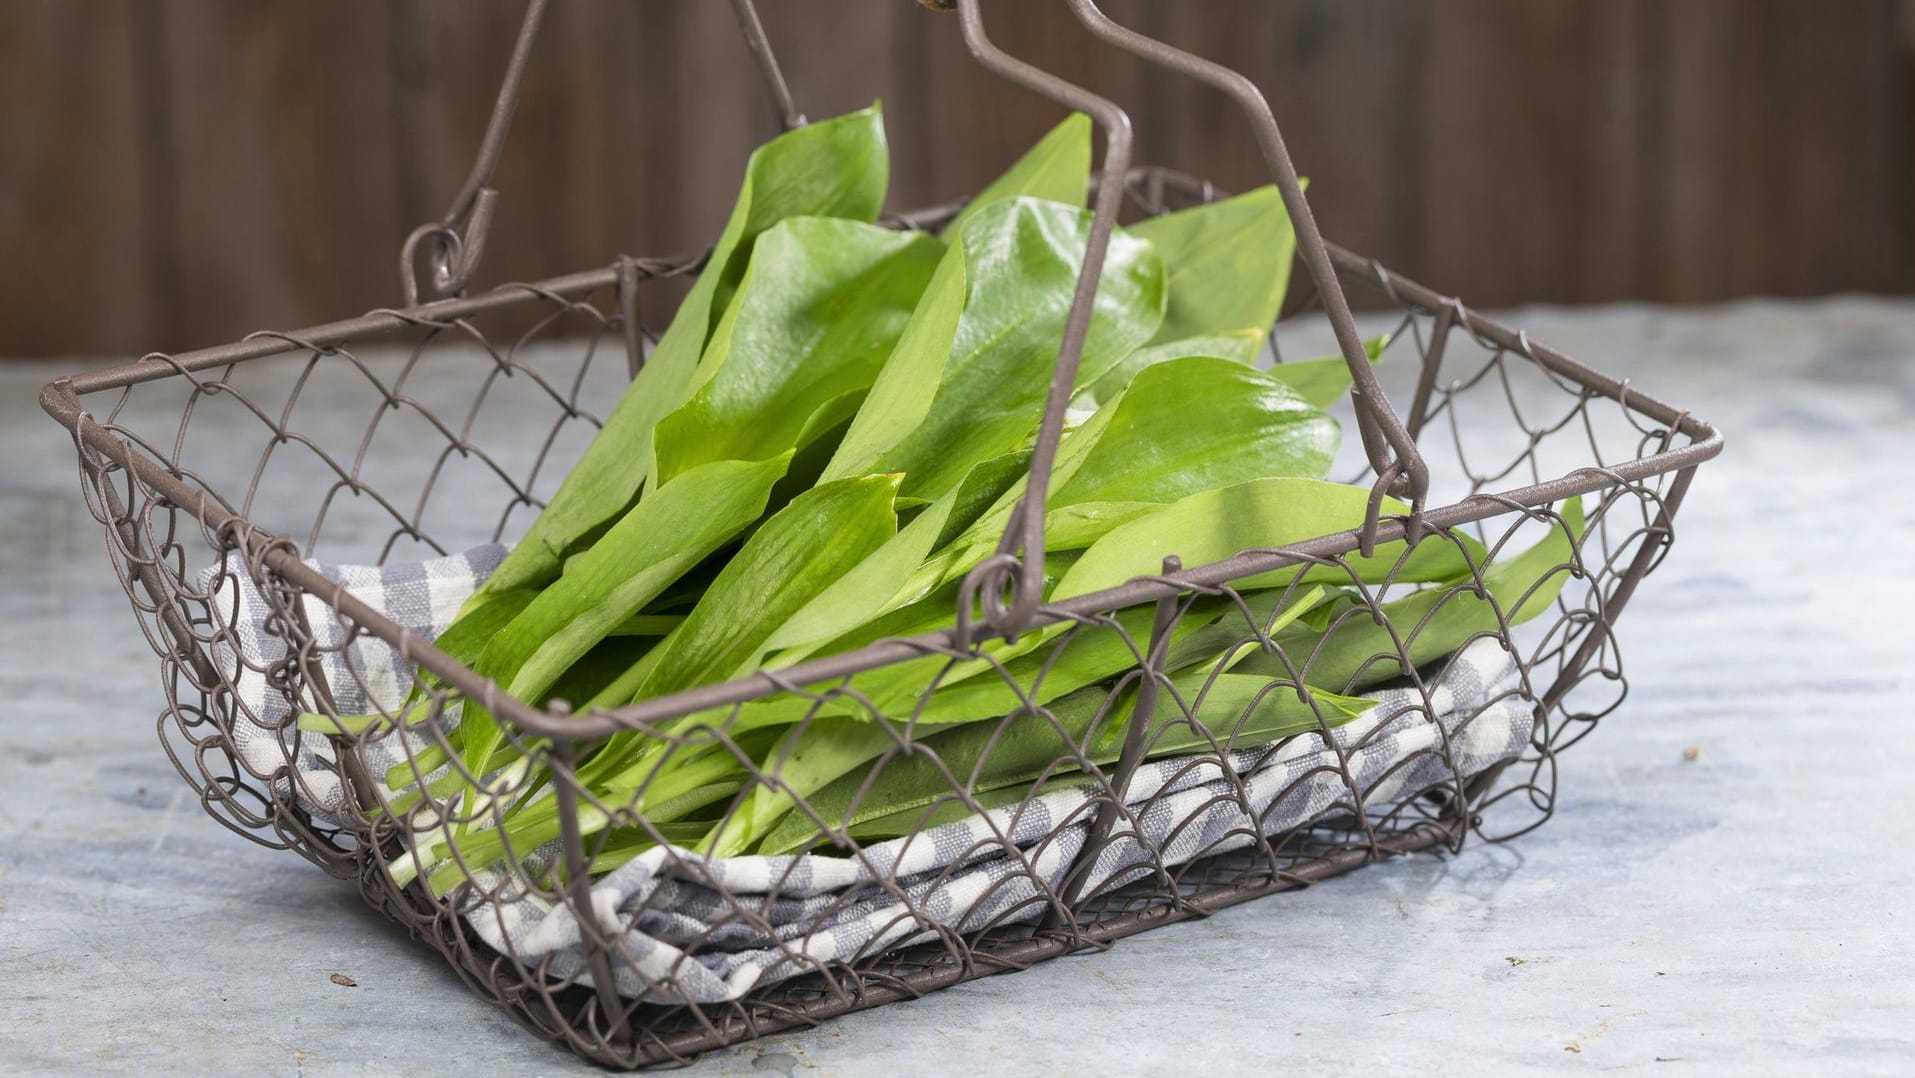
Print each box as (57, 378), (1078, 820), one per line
(40, 168), (1724, 743)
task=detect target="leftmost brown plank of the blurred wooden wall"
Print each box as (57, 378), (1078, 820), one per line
(0, 0), (153, 356)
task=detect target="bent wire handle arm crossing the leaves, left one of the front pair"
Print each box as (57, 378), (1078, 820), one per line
(958, 0), (1130, 640)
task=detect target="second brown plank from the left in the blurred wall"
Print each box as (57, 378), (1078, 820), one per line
(146, 0), (400, 350)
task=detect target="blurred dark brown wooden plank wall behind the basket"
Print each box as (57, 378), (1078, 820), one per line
(0, 0), (1915, 356)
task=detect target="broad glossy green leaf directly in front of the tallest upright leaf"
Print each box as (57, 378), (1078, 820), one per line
(653, 216), (944, 484)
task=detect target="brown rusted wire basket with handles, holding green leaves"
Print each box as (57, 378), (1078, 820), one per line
(42, 0), (1722, 1067)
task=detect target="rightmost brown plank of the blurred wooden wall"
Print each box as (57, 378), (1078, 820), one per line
(1643, 0), (1911, 303)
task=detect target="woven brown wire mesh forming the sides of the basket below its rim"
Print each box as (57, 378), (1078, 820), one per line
(48, 170), (1708, 1067)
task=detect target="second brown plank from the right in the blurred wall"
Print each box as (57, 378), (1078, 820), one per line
(1406, 0), (1658, 304)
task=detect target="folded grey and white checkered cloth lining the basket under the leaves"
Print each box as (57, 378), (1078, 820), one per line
(202, 548), (1534, 1003)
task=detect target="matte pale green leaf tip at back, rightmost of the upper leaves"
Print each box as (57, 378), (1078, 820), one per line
(1130, 180), (1296, 343)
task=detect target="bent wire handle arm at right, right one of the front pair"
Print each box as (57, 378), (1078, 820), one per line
(1065, 0), (1429, 555)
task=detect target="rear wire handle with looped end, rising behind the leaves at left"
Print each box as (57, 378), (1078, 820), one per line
(398, 0), (804, 306)
